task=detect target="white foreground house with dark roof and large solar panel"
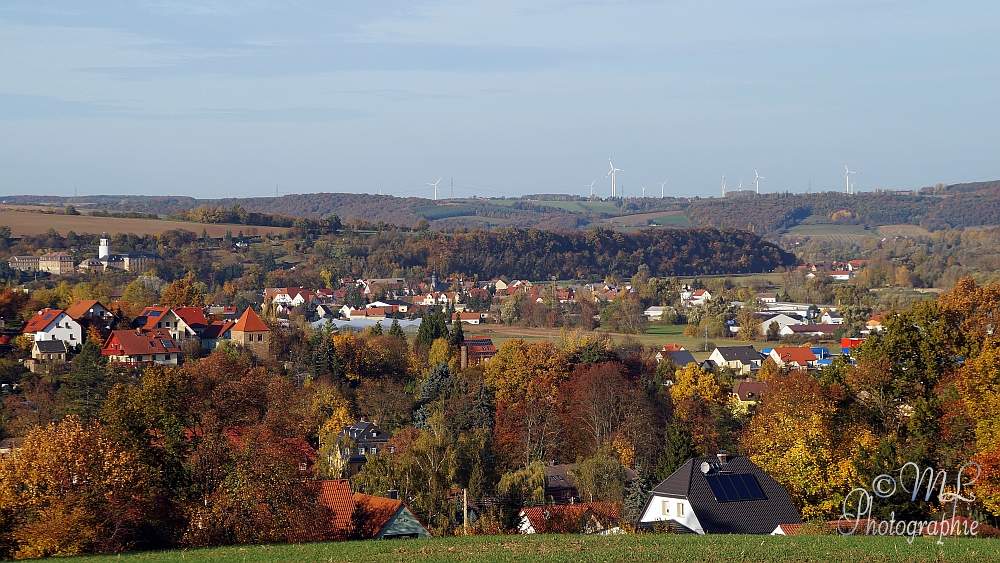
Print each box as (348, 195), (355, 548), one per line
(638, 452), (802, 534)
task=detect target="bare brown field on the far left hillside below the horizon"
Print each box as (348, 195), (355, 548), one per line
(0, 209), (246, 237)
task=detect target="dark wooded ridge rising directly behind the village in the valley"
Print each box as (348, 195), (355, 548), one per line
(336, 227), (795, 280)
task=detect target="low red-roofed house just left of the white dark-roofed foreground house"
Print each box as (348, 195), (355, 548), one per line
(518, 502), (621, 534)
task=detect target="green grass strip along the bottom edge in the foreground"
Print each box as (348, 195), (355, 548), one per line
(67, 535), (1000, 563)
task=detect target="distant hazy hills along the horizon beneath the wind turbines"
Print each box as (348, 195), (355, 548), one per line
(7, 181), (1000, 237)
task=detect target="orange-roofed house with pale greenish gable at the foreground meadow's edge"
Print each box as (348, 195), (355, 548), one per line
(318, 479), (431, 540)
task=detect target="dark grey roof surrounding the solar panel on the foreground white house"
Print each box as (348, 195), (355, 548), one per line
(643, 456), (802, 534)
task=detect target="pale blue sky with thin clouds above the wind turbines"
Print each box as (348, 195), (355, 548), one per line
(0, 0), (1000, 198)
